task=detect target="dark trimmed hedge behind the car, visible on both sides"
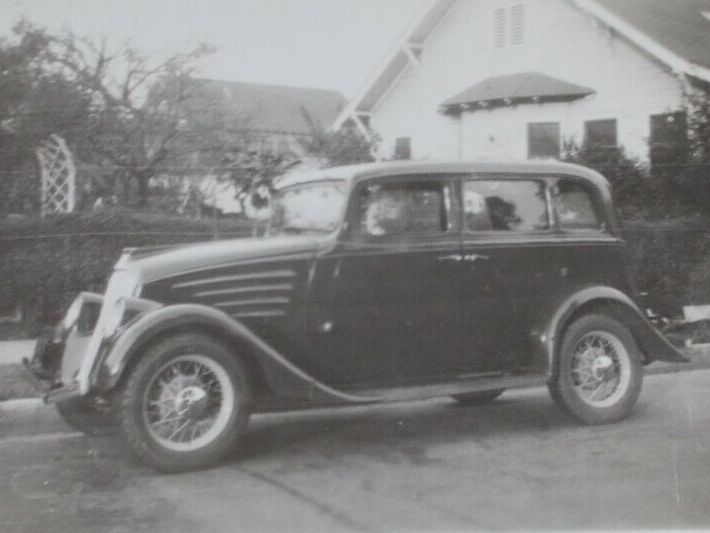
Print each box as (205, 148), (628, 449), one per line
(0, 212), (710, 337)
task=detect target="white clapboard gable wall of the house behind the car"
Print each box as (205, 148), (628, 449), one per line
(371, 0), (684, 159)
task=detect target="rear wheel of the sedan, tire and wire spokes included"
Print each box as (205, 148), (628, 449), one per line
(550, 314), (643, 424)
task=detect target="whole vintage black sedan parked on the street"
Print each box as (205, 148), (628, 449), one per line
(27, 162), (684, 472)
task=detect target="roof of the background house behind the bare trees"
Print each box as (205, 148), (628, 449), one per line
(195, 79), (345, 135)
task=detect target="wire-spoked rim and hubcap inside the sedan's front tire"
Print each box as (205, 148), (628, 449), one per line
(143, 355), (235, 451)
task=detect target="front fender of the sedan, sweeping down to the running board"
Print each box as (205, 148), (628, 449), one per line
(97, 304), (381, 403)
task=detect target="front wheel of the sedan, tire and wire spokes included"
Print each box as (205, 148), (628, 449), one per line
(121, 334), (251, 472)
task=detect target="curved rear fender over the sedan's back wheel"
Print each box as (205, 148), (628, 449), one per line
(531, 286), (688, 378)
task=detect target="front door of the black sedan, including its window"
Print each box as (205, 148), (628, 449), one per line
(308, 176), (461, 385)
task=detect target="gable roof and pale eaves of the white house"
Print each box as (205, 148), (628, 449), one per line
(334, 0), (710, 129)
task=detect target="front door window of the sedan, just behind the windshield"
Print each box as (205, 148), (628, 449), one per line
(357, 180), (449, 237)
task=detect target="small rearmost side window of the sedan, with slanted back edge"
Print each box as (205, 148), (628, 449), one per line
(552, 178), (602, 231)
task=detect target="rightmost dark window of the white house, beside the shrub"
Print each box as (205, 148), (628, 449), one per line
(650, 111), (689, 174)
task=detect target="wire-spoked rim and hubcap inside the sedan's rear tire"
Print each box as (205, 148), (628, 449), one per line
(572, 331), (631, 407)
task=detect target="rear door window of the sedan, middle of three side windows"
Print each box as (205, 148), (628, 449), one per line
(463, 179), (550, 232)
